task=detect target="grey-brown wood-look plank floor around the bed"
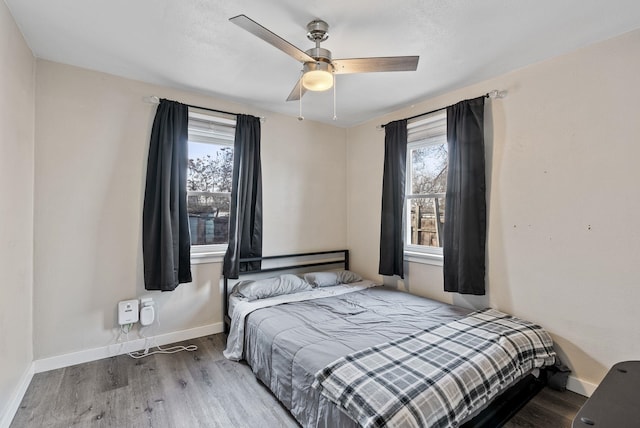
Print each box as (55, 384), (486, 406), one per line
(11, 334), (585, 428)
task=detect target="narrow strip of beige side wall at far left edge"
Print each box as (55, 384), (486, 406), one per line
(0, 2), (35, 426)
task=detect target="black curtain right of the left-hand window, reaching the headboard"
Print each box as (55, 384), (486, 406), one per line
(223, 114), (262, 278)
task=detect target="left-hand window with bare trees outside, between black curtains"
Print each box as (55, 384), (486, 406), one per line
(187, 111), (235, 253)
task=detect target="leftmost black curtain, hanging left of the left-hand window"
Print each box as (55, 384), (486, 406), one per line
(142, 99), (191, 291)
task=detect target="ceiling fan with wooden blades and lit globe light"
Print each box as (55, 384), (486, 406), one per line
(229, 15), (419, 101)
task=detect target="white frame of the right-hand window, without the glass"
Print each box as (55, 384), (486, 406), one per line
(403, 110), (447, 266)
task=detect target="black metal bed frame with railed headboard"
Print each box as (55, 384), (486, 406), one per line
(224, 250), (547, 428)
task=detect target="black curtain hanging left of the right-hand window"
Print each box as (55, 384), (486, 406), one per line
(378, 119), (407, 278)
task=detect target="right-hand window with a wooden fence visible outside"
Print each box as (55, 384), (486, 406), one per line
(405, 111), (448, 255)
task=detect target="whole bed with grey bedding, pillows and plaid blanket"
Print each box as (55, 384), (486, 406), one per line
(225, 250), (554, 428)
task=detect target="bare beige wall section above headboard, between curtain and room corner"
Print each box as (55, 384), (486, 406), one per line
(262, 113), (347, 254)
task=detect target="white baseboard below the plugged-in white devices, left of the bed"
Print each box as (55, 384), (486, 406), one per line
(33, 322), (224, 373)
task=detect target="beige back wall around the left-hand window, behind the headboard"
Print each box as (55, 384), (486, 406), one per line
(34, 60), (346, 359)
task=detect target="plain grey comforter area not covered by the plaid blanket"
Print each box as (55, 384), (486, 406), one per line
(238, 286), (471, 427)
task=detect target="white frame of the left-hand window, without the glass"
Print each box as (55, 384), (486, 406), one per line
(187, 108), (236, 264)
